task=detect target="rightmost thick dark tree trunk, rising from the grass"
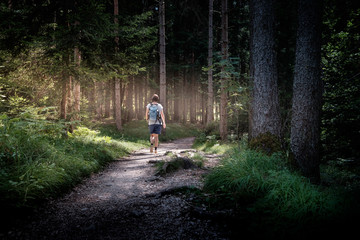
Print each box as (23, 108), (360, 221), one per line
(291, 0), (322, 182)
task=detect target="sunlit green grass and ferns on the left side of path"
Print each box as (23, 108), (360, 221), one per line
(0, 115), (195, 207)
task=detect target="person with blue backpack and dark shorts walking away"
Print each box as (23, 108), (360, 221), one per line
(145, 94), (166, 154)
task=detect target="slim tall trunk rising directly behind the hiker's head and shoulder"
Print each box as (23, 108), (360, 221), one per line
(159, 1), (167, 121)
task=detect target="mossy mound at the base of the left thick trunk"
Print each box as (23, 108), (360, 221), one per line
(249, 132), (282, 156)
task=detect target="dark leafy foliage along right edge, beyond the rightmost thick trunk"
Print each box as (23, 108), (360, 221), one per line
(322, 1), (360, 160)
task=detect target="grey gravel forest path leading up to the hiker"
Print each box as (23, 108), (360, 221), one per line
(0, 138), (233, 239)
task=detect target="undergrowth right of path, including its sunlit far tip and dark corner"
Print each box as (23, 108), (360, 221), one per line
(194, 129), (360, 238)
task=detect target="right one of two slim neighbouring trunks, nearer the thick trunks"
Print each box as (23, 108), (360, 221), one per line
(220, 0), (228, 141)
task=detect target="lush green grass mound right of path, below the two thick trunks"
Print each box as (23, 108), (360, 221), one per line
(200, 147), (359, 236)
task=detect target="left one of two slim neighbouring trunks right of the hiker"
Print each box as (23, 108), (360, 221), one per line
(206, 0), (214, 125)
